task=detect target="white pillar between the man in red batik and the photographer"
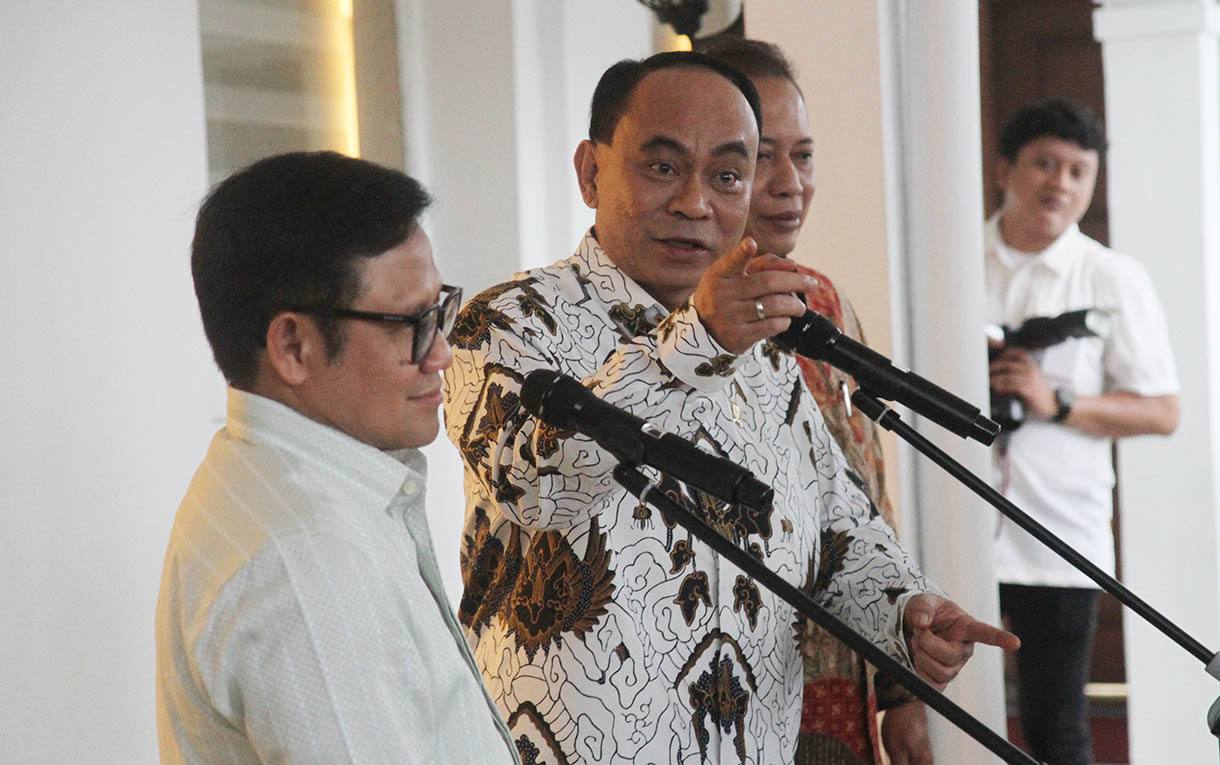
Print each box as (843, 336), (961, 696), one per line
(883, 0), (1005, 763)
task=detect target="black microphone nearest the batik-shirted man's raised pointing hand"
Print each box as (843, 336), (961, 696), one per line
(772, 311), (999, 445)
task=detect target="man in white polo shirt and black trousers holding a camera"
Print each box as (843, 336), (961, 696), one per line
(985, 101), (1179, 765)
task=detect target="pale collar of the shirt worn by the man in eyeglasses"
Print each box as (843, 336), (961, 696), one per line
(227, 387), (427, 519)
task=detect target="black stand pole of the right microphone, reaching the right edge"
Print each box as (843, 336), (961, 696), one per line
(852, 388), (1220, 756)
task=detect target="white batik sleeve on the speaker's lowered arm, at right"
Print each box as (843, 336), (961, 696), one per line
(794, 385), (941, 665)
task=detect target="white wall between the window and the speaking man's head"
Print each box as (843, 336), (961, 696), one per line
(397, 0), (653, 604)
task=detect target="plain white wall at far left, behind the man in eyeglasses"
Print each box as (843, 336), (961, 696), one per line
(0, 0), (223, 763)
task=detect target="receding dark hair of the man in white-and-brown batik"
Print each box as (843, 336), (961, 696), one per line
(589, 50), (763, 144)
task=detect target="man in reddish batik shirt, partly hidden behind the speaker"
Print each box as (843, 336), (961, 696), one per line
(700, 34), (932, 765)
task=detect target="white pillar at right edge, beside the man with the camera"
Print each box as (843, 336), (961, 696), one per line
(1093, 0), (1220, 765)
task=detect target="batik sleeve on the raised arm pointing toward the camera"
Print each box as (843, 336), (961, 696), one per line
(445, 277), (738, 530)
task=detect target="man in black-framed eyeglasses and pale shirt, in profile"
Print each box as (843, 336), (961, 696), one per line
(156, 153), (519, 763)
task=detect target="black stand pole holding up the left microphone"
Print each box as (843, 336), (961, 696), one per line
(614, 461), (1037, 765)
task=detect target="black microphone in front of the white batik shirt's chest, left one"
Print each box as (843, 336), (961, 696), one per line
(521, 370), (775, 510)
